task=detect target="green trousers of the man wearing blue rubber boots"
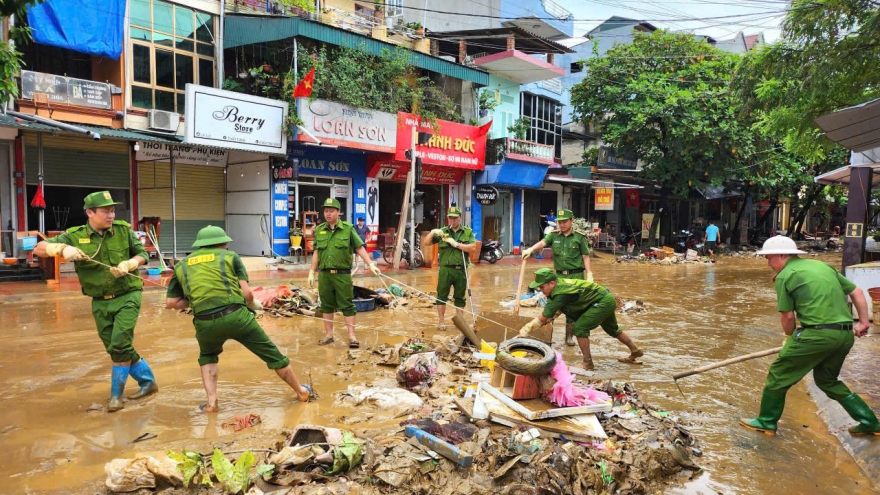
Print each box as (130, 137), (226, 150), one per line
(92, 290), (142, 364)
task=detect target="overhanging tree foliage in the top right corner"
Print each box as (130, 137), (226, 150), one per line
(733, 0), (880, 161)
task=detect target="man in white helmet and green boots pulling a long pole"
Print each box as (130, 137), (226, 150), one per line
(739, 235), (880, 435)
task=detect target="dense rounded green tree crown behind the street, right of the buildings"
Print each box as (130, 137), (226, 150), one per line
(571, 31), (754, 195)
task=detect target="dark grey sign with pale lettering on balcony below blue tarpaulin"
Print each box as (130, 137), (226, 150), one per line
(21, 70), (113, 109)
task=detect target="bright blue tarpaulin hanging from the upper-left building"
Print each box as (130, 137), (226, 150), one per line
(28, 0), (125, 60)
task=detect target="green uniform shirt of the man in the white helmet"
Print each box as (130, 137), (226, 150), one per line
(774, 257), (856, 325)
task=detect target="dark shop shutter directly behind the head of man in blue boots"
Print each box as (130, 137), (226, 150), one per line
(24, 133), (131, 189)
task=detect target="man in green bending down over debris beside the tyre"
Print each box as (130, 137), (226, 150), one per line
(519, 268), (645, 370)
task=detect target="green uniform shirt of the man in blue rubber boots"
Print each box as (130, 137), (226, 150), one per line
(46, 220), (149, 297)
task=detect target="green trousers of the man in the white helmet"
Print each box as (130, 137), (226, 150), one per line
(764, 328), (855, 401)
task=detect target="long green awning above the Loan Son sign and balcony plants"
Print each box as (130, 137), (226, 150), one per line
(223, 15), (489, 86)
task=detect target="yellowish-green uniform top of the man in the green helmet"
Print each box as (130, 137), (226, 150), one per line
(165, 247), (248, 314)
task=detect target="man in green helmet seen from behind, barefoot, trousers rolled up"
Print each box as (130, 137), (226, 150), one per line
(165, 225), (309, 412)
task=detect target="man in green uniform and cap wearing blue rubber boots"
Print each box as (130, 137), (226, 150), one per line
(34, 191), (159, 412)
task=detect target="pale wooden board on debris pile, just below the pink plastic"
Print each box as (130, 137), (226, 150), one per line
(481, 393), (608, 442)
